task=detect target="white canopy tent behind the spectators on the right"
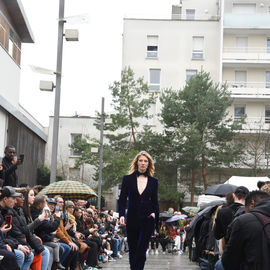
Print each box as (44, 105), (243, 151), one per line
(224, 176), (270, 191)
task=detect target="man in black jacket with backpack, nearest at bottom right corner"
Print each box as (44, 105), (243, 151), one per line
(215, 190), (270, 270)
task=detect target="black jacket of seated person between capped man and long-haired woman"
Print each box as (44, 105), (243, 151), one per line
(7, 207), (44, 254)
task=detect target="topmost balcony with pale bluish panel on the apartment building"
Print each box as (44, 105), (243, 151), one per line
(224, 13), (270, 33)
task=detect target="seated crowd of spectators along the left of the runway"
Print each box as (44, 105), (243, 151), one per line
(0, 186), (128, 270)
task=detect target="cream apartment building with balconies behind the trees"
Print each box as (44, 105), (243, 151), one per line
(122, 0), (270, 181)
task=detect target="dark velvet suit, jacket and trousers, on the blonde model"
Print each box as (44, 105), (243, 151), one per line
(118, 172), (159, 270)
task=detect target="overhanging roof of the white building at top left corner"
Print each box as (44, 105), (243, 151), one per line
(3, 0), (34, 43)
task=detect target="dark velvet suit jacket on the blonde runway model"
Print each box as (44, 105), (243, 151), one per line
(118, 172), (159, 226)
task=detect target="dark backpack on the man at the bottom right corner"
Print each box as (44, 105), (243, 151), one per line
(251, 212), (270, 270)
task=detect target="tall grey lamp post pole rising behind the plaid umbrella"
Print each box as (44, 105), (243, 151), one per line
(50, 0), (65, 183)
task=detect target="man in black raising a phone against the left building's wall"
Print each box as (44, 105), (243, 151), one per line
(2, 145), (22, 187)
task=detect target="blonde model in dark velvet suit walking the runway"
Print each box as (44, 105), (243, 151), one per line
(118, 151), (159, 270)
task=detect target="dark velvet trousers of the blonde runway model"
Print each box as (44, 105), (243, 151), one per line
(127, 217), (155, 270)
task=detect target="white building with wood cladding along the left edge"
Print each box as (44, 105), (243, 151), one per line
(0, 0), (47, 185)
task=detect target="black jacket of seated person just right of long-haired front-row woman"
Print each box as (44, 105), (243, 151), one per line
(31, 206), (60, 242)
